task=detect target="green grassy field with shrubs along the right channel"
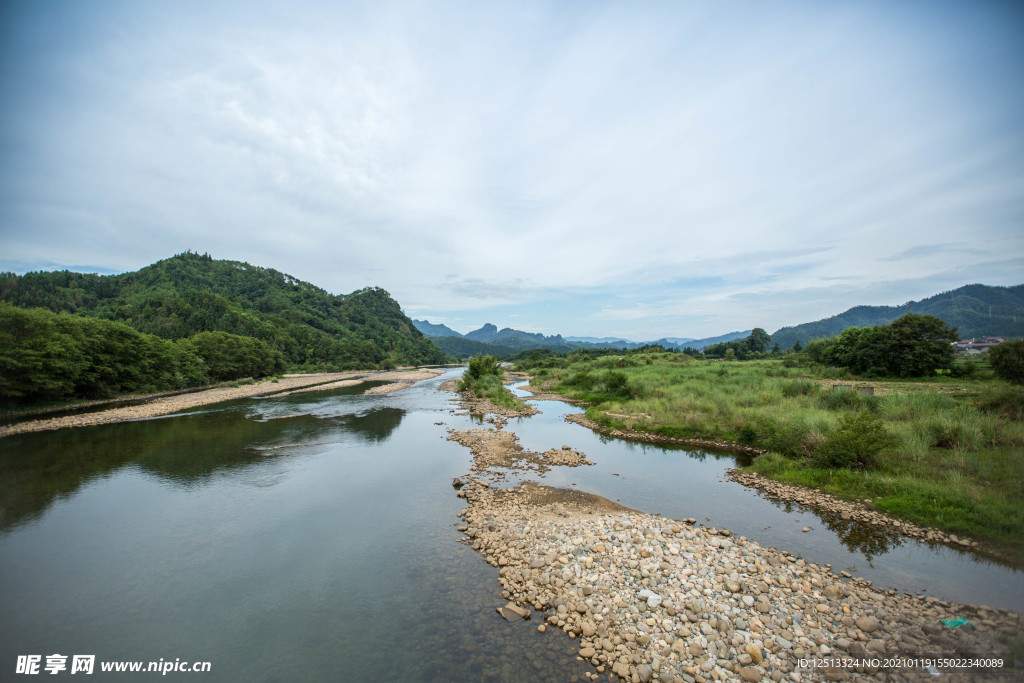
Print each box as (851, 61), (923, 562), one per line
(518, 353), (1024, 560)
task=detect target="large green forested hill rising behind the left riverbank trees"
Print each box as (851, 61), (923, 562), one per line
(0, 252), (445, 370)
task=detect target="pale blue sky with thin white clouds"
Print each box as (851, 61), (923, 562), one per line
(0, 0), (1024, 340)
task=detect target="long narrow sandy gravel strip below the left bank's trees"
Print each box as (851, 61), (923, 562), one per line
(0, 370), (442, 438)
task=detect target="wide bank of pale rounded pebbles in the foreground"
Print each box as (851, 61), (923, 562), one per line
(460, 479), (1024, 683)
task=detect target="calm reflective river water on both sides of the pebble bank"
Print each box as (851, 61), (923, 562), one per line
(0, 371), (1024, 681)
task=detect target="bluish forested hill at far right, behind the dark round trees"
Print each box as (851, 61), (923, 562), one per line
(771, 285), (1024, 349)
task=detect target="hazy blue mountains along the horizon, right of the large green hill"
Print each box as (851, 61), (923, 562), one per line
(413, 285), (1024, 356)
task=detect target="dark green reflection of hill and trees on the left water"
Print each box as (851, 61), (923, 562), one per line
(0, 407), (404, 530)
